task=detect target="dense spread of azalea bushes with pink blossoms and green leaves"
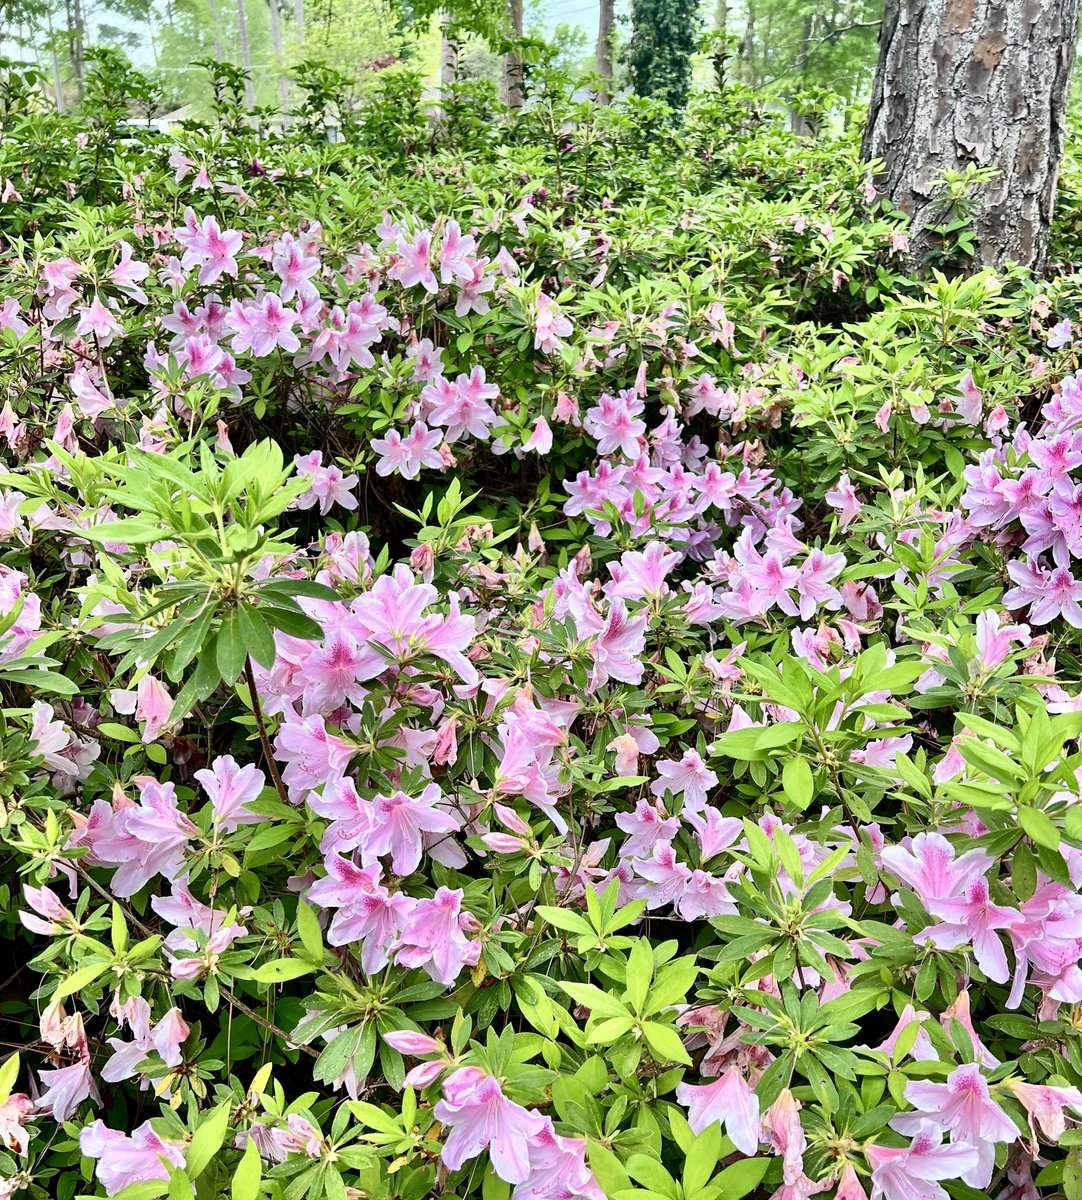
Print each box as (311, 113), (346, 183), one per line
(0, 49), (1082, 1200)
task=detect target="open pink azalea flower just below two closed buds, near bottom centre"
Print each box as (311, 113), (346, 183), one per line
(433, 1067), (545, 1184)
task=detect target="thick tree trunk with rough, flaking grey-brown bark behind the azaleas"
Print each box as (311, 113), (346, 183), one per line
(862, 0), (1078, 271)
